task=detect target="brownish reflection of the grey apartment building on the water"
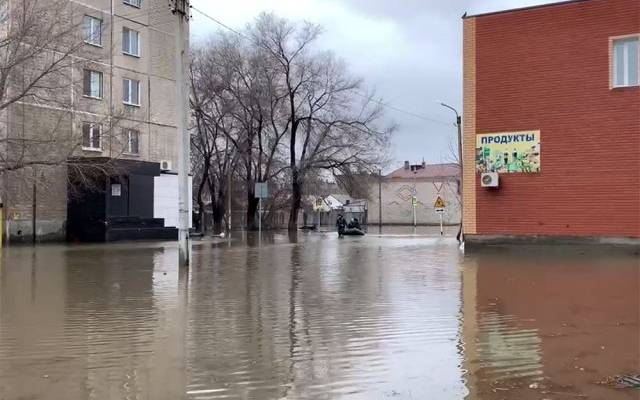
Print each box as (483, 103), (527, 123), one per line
(0, 246), (188, 399)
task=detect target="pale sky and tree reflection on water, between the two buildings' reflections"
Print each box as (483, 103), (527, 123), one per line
(187, 233), (465, 399)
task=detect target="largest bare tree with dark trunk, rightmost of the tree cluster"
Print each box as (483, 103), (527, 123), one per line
(251, 14), (392, 230)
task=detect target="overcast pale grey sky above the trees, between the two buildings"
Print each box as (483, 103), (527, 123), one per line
(191, 0), (554, 167)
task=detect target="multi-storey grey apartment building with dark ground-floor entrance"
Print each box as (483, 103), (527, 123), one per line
(2, 0), (188, 241)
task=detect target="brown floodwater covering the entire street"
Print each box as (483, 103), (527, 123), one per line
(0, 228), (640, 400)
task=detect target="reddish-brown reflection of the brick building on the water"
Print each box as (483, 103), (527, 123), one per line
(462, 248), (640, 399)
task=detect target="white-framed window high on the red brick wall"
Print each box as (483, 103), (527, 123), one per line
(612, 36), (640, 87)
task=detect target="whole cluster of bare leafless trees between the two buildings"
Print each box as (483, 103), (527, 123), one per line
(192, 14), (392, 230)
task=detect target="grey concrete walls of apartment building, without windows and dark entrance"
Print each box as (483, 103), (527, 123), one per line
(0, 0), (179, 242)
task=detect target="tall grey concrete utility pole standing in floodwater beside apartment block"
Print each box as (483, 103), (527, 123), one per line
(170, 0), (191, 266)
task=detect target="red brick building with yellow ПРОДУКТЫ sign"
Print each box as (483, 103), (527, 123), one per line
(463, 0), (640, 243)
